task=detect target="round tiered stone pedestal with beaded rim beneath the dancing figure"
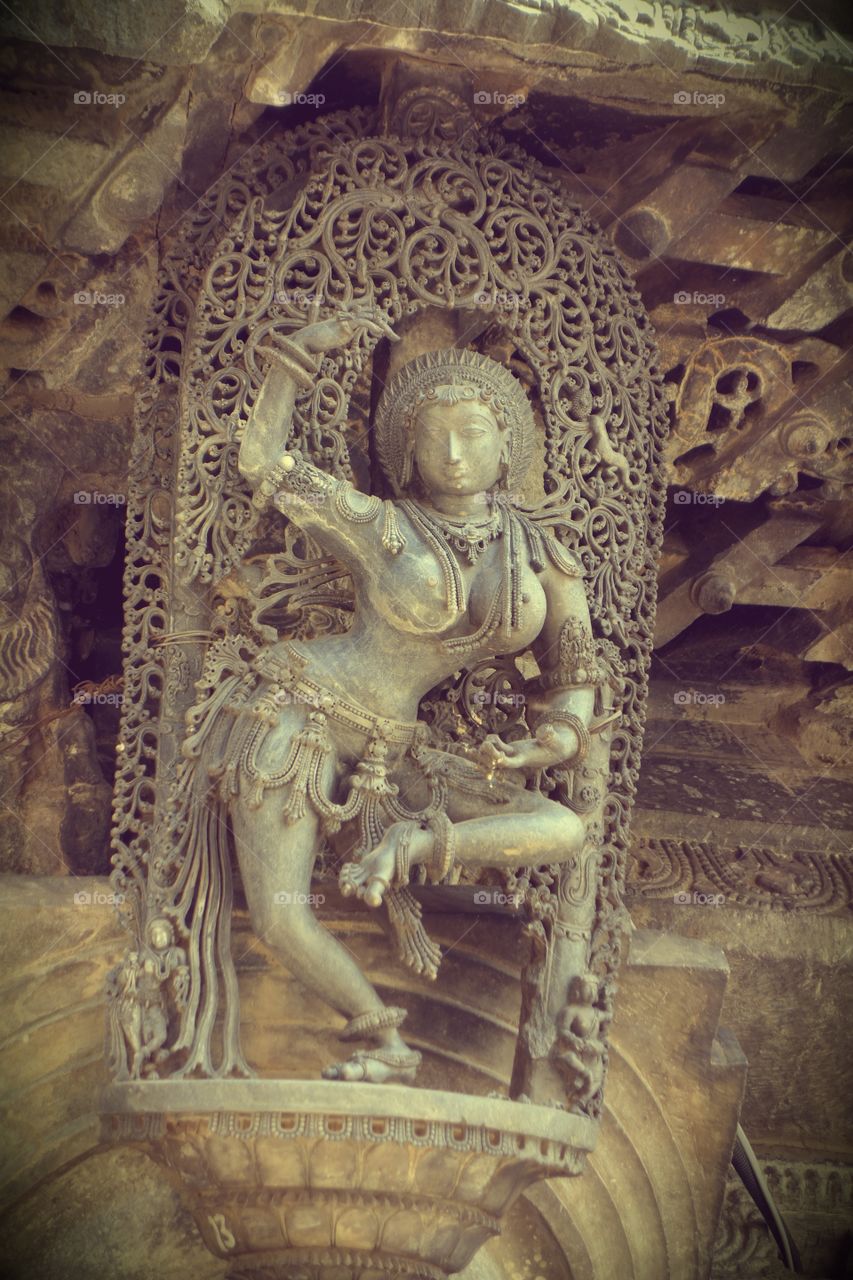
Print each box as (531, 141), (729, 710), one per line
(104, 1080), (597, 1280)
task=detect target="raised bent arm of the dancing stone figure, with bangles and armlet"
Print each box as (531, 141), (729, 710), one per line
(238, 308), (397, 559)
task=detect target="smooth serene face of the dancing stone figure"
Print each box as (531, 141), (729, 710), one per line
(415, 388), (506, 497)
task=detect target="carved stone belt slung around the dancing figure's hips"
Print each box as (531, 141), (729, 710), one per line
(244, 645), (429, 746)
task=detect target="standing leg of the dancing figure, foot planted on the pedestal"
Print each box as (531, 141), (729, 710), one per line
(231, 790), (419, 1082)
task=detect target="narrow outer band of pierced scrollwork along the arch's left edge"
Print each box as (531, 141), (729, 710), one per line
(113, 109), (375, 1051)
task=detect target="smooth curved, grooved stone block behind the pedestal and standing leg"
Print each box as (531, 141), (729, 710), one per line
(0, 877), (743, 1280)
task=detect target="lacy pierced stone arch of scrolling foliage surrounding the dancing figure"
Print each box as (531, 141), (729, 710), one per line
(109, 113), (666, 1106)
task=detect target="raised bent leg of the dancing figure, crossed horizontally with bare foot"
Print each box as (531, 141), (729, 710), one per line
(341, 792), (584, 906)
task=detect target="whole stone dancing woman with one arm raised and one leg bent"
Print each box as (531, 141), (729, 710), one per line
(184, 304), (601, 1082)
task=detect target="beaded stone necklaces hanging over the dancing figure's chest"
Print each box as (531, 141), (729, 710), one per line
(400, 498), (523, 654)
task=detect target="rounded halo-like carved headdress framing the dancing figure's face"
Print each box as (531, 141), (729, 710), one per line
(374, 347), (534, 497)
